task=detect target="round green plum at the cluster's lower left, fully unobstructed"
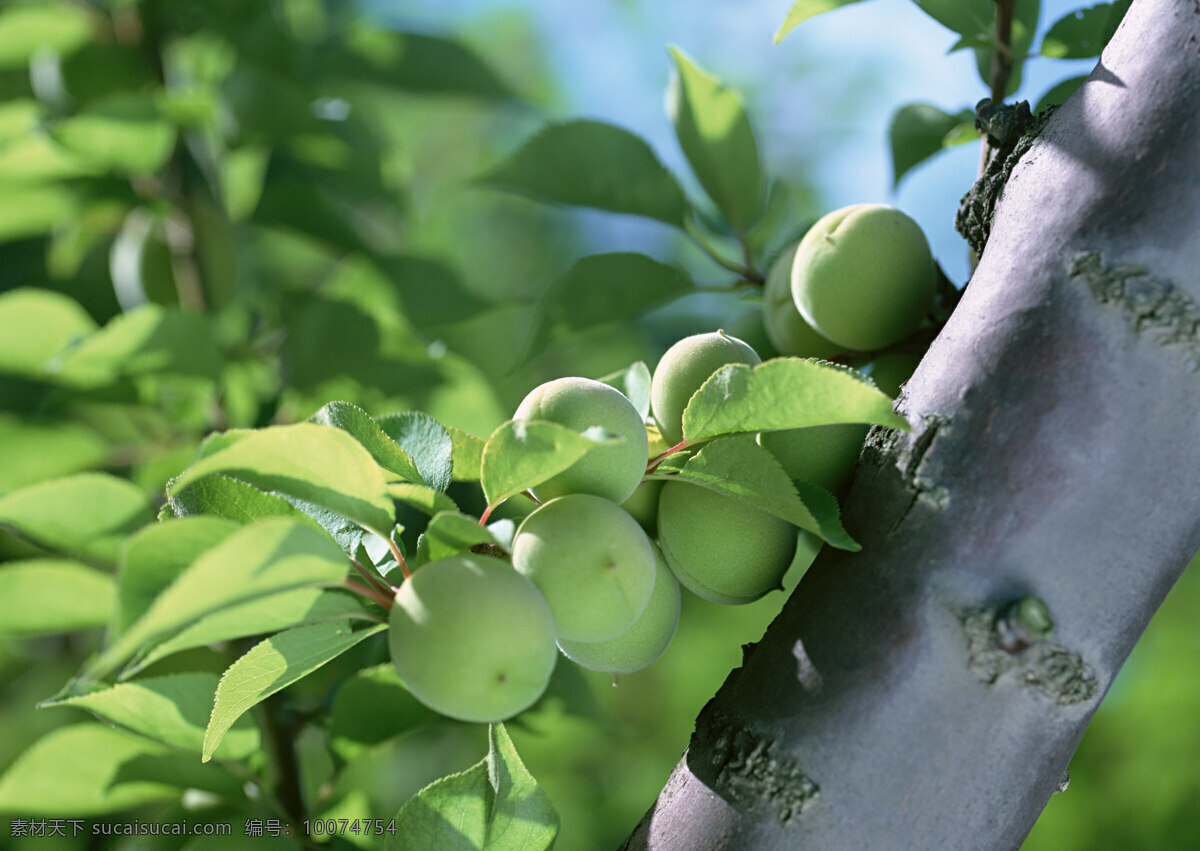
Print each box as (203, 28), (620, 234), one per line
(388, 555), (558, 723)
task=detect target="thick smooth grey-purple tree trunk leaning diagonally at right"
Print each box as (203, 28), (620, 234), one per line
(626, 0), (1200, 851)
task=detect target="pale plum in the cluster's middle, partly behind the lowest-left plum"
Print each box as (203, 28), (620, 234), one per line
(512, 493), (654, 641)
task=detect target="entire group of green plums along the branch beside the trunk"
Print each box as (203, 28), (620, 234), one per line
(390, 205), (934, 721)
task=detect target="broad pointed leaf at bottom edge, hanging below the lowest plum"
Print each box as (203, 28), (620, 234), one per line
(393, 724), (559, 851)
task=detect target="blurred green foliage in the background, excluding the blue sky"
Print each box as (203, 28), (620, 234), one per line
(0, 0), (1200, 850)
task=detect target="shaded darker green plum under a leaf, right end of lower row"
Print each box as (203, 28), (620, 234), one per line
(659, 481), (797, 605)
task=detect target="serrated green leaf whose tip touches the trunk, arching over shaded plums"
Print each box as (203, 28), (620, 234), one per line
(683, 358), (910, 443)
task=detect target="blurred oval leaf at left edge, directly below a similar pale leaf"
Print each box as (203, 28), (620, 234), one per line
(0, 558), (116, 635)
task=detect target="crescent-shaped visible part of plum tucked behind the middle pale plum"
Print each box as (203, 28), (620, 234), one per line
(558, 540), (680, 673)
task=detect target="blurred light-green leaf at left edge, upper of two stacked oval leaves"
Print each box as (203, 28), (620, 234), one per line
(0, 473), (154, 563)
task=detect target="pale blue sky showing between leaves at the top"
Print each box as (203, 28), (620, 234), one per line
(374, 0), (1093, 283)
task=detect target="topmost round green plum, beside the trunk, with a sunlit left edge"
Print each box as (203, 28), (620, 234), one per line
(792, 204), (936, 352)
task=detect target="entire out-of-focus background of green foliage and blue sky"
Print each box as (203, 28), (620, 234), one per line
(0, 0), (1200, 851)
